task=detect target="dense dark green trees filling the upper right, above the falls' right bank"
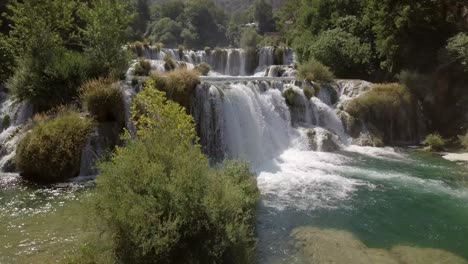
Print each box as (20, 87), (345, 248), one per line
(275, 0), (468, 137)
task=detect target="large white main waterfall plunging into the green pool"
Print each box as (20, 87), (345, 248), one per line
(192, 78), (350, 165)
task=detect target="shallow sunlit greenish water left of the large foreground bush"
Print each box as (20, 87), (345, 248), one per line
(0, 177), (92, 263)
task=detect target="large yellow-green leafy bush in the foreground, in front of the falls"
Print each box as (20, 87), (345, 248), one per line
(94, 89), (259, 263)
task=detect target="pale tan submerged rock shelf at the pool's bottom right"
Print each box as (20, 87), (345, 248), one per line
(291, 227), (468, 264)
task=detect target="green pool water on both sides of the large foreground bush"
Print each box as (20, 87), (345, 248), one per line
(0, 148), (468, 263)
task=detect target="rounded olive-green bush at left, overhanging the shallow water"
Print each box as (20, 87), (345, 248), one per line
(16, 111), (93, 183)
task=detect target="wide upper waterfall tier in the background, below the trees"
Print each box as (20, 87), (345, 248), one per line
(130, 46), (295, 76)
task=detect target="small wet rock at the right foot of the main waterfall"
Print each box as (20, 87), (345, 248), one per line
(307, 128), (340, 152)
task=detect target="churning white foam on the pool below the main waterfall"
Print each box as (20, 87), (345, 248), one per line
(257, 149), (369, 210)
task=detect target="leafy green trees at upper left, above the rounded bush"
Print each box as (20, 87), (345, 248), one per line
(0, 0), (132, 110)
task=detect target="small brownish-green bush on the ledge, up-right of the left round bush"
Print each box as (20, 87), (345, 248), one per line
(80, 78), (125, 126)
